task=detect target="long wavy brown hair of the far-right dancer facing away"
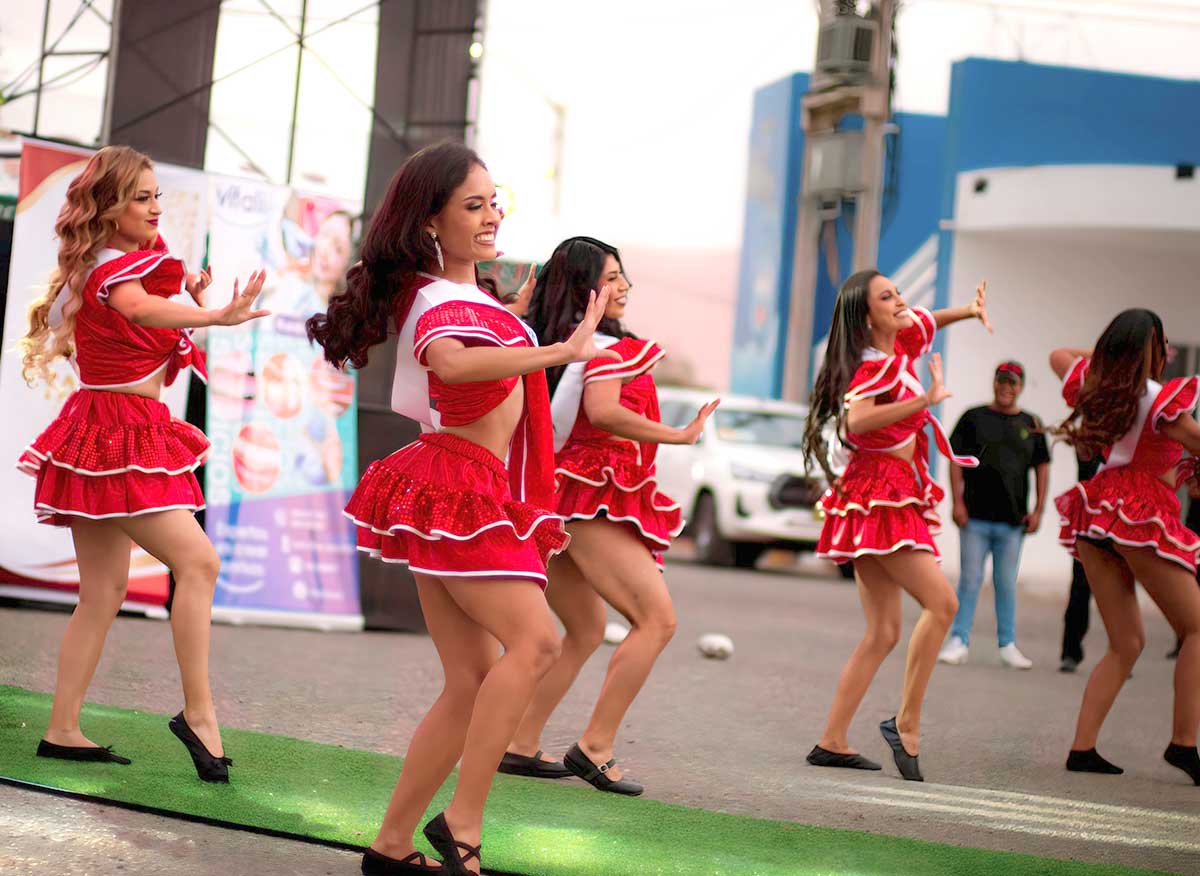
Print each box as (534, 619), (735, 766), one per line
(1058, 307), (1166, 458)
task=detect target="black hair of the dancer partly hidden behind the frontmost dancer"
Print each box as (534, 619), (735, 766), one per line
(526, 238), (634, 394)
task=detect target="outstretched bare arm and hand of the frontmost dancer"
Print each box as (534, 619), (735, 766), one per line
(425, 289), (620, 383)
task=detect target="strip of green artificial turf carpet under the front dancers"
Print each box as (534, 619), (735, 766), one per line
(0, 685), (1180, 876)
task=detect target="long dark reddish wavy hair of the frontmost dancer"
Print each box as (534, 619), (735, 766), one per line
(306, 140), (496, 368)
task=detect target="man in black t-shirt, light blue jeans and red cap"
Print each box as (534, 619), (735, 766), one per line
(937, 361), (1050, 670)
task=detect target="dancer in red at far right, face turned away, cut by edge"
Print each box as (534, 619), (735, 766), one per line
(1050, 307), (1200, 785)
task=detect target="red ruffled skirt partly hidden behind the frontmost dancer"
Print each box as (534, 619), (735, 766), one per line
(554, 440), (683, 560)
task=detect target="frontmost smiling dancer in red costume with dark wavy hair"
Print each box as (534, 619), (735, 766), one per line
(308, 143), (617, 876)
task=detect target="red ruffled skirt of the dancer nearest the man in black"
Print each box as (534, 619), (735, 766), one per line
(816, 451), (943, 563)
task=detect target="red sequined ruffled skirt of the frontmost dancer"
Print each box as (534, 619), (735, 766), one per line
(346, 432), (570, 587)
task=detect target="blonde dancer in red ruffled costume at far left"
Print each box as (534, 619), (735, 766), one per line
(17, 146), (265, 781)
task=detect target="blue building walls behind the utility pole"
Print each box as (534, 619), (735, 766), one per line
(732, 58), (1200, 397)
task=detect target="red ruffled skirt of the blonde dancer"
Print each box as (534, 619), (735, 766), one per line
(17, 389), (209, 526)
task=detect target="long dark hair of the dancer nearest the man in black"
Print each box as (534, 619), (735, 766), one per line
(804, 268), (882, 484)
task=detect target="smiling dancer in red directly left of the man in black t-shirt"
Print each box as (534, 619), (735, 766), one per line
(804, 270), (991, 781)
